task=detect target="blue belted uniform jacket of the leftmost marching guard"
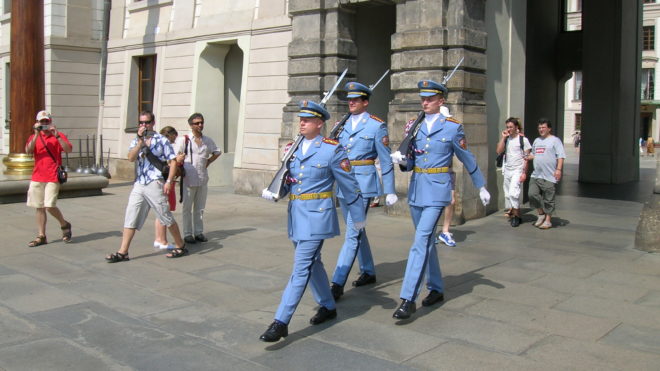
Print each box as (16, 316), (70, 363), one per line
(287, 136), (365, 241)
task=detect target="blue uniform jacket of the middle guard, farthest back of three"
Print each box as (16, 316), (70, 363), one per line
(337, 115), (395, 198)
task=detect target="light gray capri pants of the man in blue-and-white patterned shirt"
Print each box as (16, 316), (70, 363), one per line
(124, 180), (176, 230)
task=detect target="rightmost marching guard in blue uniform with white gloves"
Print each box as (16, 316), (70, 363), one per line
(391, 80), (490, 319)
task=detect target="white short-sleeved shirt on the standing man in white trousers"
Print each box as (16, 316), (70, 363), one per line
(174, 135), (221, 187)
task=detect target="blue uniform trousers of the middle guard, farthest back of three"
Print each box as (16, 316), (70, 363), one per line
(332, 197), (376, 286)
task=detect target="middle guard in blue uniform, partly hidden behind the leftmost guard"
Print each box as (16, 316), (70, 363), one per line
(331, 82), (398, 300)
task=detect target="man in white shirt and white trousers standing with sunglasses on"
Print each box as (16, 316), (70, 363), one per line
(175, 113), (222, 243)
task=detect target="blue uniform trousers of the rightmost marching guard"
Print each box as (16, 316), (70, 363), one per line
(400, 205), (444, 301)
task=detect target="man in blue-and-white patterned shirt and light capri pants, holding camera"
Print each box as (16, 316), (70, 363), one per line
(105, 111), (188, 263)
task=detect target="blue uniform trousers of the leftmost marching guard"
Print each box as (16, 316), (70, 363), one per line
(275, 240), (335, 324)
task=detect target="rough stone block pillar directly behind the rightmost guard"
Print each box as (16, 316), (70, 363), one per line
(387, 0), (488, 220)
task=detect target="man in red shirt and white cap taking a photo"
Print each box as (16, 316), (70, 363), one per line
(25, 111), (73, 247)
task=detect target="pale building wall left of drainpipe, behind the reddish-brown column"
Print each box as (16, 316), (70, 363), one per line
(0, 0), (103, 154)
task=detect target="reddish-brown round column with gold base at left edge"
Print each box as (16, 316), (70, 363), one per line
(3, 0), (45, 175)
